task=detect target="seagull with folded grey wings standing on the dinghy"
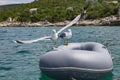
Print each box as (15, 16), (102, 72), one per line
(59, 29), (72, 45)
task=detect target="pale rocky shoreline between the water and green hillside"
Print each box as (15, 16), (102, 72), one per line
(0, 15), (120, 27)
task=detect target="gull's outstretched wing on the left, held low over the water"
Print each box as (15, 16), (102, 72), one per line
(14, 36), (51, 44)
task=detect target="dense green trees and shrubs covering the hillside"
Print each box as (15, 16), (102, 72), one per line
(0, 0), (119, 22)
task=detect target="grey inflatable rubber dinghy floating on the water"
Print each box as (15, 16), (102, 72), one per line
(39, 42), (113, 80)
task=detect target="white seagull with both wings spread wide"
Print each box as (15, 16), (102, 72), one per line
(14, 10), (86, 45)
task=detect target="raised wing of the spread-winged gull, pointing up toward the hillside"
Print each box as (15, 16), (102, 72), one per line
(57, 10), (86, 34)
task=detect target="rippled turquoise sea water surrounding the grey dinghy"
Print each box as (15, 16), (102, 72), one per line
(0, 26), (120, 80)
